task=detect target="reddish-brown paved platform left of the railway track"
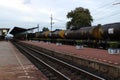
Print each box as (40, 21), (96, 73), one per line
(0, 41), (48, 80)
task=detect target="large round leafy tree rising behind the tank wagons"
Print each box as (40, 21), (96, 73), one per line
(66, 7), (93, 29)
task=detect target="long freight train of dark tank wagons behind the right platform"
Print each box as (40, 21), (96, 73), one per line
(15, 22), (120, 49)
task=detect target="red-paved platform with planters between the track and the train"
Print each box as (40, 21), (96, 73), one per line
(21, 41), (120, 67)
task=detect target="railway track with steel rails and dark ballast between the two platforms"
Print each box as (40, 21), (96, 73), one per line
(13, 43), (105, 80)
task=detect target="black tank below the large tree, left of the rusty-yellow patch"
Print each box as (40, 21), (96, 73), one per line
(65, 26), (96, 40)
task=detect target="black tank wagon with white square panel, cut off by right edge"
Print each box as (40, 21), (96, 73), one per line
(102, 23), (120, 41)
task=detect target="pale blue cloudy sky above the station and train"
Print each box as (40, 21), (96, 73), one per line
(0, 0), (120, 30)
